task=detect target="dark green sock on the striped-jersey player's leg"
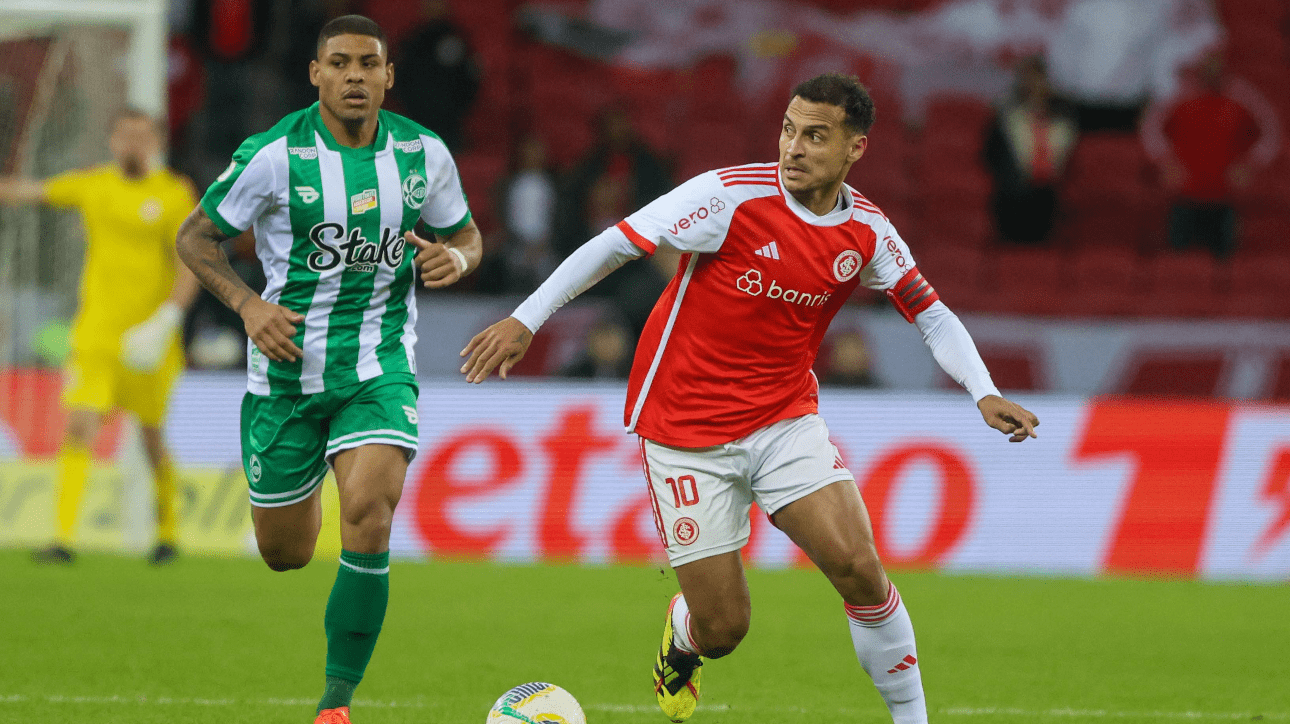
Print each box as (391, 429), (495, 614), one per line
(319, 550), (390, 711)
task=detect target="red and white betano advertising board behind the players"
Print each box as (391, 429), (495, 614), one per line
(0, 373), (1290, 581)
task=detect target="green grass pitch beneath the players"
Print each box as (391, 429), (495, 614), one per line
(0, 551), (1290, 724)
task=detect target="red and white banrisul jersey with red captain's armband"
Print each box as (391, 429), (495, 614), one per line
(618, 164), (938, 448)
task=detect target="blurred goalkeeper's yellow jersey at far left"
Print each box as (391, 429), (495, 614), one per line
(44, 165), (197, 357)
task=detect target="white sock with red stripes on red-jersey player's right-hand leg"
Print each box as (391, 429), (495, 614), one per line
(844, 585), (928, 724)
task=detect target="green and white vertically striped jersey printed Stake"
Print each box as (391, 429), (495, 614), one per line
(201, 103), (471, 395)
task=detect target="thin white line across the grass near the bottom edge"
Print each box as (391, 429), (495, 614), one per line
(0, 694), (1290, 721)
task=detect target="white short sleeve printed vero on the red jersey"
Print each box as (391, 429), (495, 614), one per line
(617, 172), (738, 254)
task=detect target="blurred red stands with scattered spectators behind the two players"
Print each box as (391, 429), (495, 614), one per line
(108, 0), (1290, 385)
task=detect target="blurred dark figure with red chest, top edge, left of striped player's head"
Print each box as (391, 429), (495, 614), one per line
(192, 0), (272, 159)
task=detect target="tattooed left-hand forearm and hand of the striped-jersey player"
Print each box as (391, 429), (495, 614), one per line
(174, 206), (304, 361)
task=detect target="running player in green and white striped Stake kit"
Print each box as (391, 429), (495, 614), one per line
(177, 15), (482, 724)
